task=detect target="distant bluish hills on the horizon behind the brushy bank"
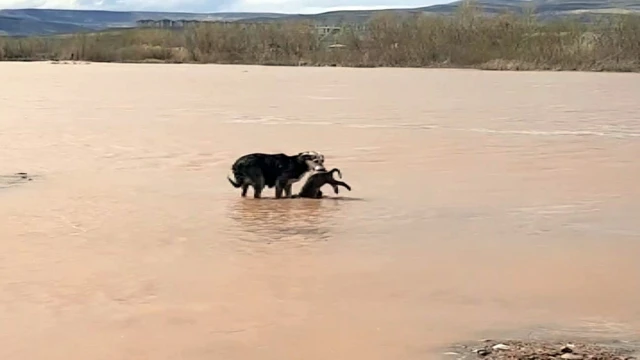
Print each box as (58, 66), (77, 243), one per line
(0, 0), (640, 36)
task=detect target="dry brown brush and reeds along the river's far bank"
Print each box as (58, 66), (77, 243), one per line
(0, 3), (640, 71)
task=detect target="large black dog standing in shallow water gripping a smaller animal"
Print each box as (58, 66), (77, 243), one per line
(227, 151), (325, 199)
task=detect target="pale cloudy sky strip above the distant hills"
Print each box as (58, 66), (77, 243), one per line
(0, 0), (451, 13)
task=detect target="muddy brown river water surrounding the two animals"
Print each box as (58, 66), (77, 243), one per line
(0, 63), (640, 360)
